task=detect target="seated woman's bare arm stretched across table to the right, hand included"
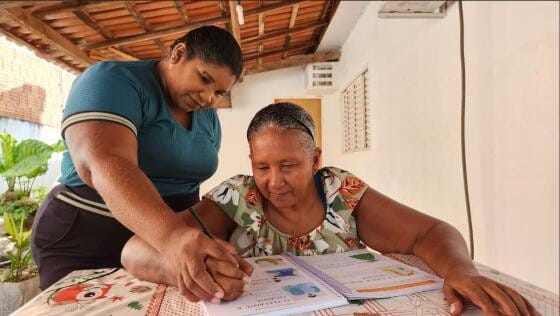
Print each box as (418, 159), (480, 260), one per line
(354, 188), (538, 315)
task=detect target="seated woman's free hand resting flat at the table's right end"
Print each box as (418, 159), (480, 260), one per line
(443, 272), (540, 315)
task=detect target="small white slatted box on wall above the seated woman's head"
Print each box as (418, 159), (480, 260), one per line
(305, 62), (337, 95)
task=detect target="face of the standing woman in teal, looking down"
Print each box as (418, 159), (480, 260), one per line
(166, 44), (237, 112)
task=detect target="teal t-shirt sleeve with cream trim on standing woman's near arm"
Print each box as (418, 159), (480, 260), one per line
(62, 62), (142, 138)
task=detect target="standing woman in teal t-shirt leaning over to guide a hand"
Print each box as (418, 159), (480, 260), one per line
(32, 26), (247, 301)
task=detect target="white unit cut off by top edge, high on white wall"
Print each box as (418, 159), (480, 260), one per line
(377, 1), (447, 18)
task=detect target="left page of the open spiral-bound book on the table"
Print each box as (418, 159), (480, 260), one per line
(205, 256), (348, 316)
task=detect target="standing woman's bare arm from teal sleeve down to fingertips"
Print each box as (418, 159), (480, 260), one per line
(65, 121), (241, 301)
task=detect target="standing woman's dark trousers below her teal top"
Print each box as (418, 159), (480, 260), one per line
(31, 185), (199, 290)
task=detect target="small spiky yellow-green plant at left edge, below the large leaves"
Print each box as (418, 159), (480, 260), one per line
(0, 212), (37, 282)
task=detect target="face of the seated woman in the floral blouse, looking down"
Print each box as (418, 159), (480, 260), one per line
(249, 127), (320, 208)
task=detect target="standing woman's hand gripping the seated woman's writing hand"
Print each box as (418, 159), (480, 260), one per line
(162, 225), (241, 303)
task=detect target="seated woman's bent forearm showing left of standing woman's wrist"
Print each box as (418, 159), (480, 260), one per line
(121, 236), (177, 286)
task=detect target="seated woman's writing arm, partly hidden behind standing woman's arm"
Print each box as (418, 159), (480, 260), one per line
(121, 199), (253, 300)
